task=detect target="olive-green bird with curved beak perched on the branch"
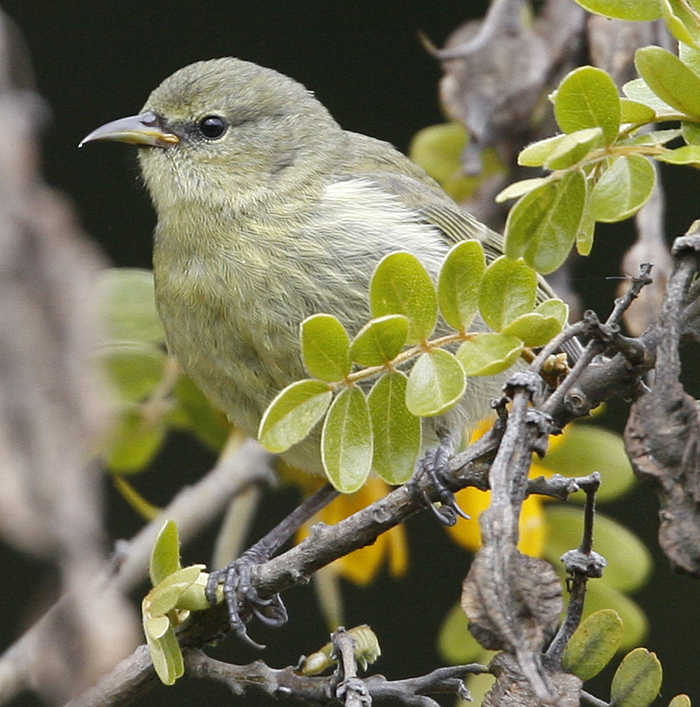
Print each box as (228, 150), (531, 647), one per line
(83, 58), (564, 636)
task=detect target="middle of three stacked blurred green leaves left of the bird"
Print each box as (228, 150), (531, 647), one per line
(97, 342), (167, 403)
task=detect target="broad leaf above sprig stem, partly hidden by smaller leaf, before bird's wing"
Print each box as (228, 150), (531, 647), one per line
(370, 252), (438, 344)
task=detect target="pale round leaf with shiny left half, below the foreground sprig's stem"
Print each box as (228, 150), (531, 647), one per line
(406, 349), (467, 417)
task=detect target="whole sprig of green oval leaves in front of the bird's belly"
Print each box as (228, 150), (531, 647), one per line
(259, 241), (568, 493)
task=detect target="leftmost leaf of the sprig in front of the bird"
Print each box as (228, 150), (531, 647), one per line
(258, 380), (333, 454)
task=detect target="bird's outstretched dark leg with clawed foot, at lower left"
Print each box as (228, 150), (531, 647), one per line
(206, 484), (339, 648)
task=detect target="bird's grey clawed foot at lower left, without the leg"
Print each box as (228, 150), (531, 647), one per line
(205, 548), (288, 649)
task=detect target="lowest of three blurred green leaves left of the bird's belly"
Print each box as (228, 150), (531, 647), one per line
(106, 410), (166, 474)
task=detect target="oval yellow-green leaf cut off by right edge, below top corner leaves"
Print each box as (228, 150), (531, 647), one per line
(634, 46), (700, 120)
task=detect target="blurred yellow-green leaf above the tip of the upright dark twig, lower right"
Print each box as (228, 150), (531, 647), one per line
(542, 424), (635, 503)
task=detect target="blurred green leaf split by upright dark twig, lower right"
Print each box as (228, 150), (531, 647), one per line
(545, 505), (653, 596)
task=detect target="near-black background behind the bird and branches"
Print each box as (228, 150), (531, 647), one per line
(0, 0), (700, 705)
